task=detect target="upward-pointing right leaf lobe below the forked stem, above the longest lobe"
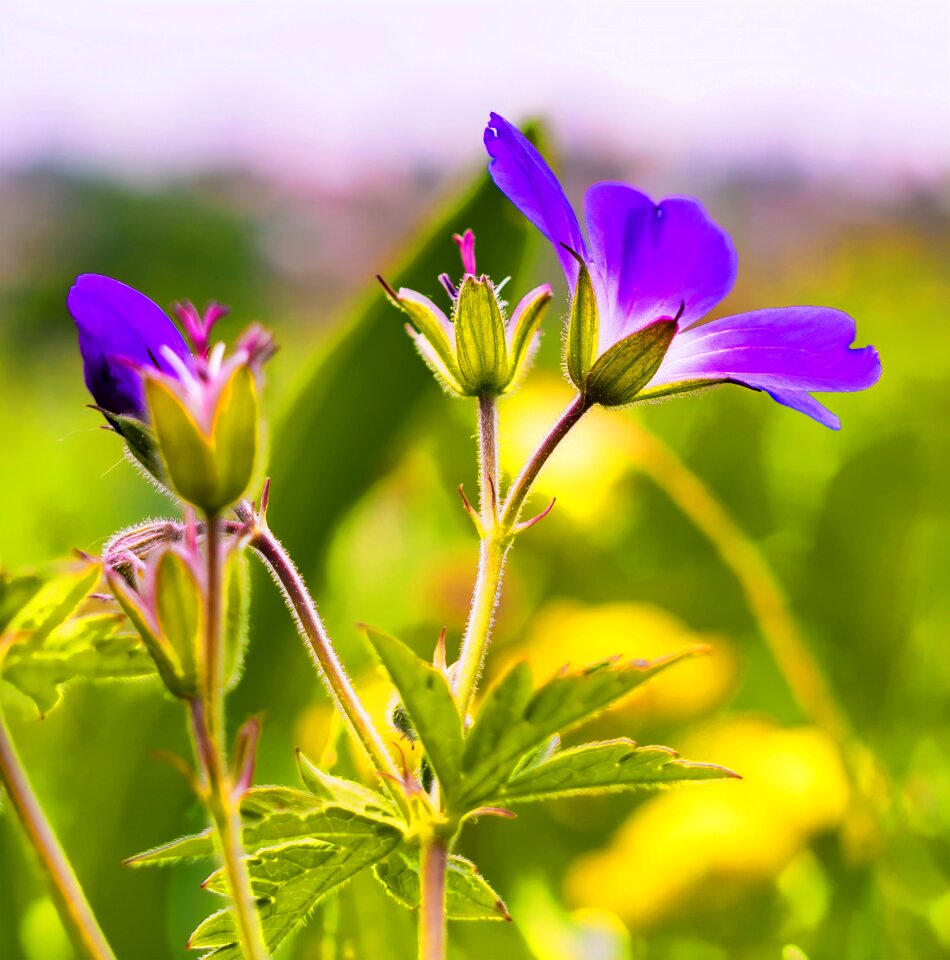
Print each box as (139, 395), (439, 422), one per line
(461, 647), (706, 808)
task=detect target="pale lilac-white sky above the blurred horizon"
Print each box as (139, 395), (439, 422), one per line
(0, 0), (950, 181)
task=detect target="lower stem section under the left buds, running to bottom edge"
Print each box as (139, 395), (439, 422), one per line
(189, 699), (270, 960)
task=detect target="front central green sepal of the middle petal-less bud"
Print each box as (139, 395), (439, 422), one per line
(453, 276), (508, 396)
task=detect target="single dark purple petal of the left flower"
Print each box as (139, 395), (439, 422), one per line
(66, 273), (195, 419)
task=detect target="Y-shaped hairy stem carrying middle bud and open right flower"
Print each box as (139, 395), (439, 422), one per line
(455, 395), (591, 715)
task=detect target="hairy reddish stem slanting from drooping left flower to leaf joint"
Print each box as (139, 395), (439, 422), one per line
(245, 524), (405, 802)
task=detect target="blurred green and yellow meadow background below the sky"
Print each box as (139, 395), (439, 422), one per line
(0, 4), (950, 960)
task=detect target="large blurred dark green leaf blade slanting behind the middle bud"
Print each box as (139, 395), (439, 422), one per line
(249, 128), (540, 725)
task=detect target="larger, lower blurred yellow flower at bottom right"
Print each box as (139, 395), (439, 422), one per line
(567, 717), (849, 927)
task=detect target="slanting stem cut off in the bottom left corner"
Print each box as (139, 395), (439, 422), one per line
(0, 700), (115, 960)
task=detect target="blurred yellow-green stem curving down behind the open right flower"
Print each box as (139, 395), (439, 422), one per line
(636, 424), (853, 750)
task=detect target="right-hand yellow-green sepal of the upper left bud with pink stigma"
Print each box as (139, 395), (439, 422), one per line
(211, 365), (259, 506)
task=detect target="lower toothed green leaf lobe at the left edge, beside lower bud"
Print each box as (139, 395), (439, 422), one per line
(2, 613), (155, 714)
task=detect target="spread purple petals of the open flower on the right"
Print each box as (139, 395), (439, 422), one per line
(485, 113), (881, 429)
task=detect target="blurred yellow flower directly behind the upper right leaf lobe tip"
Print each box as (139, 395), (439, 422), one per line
(498, 600), (738, 721)
